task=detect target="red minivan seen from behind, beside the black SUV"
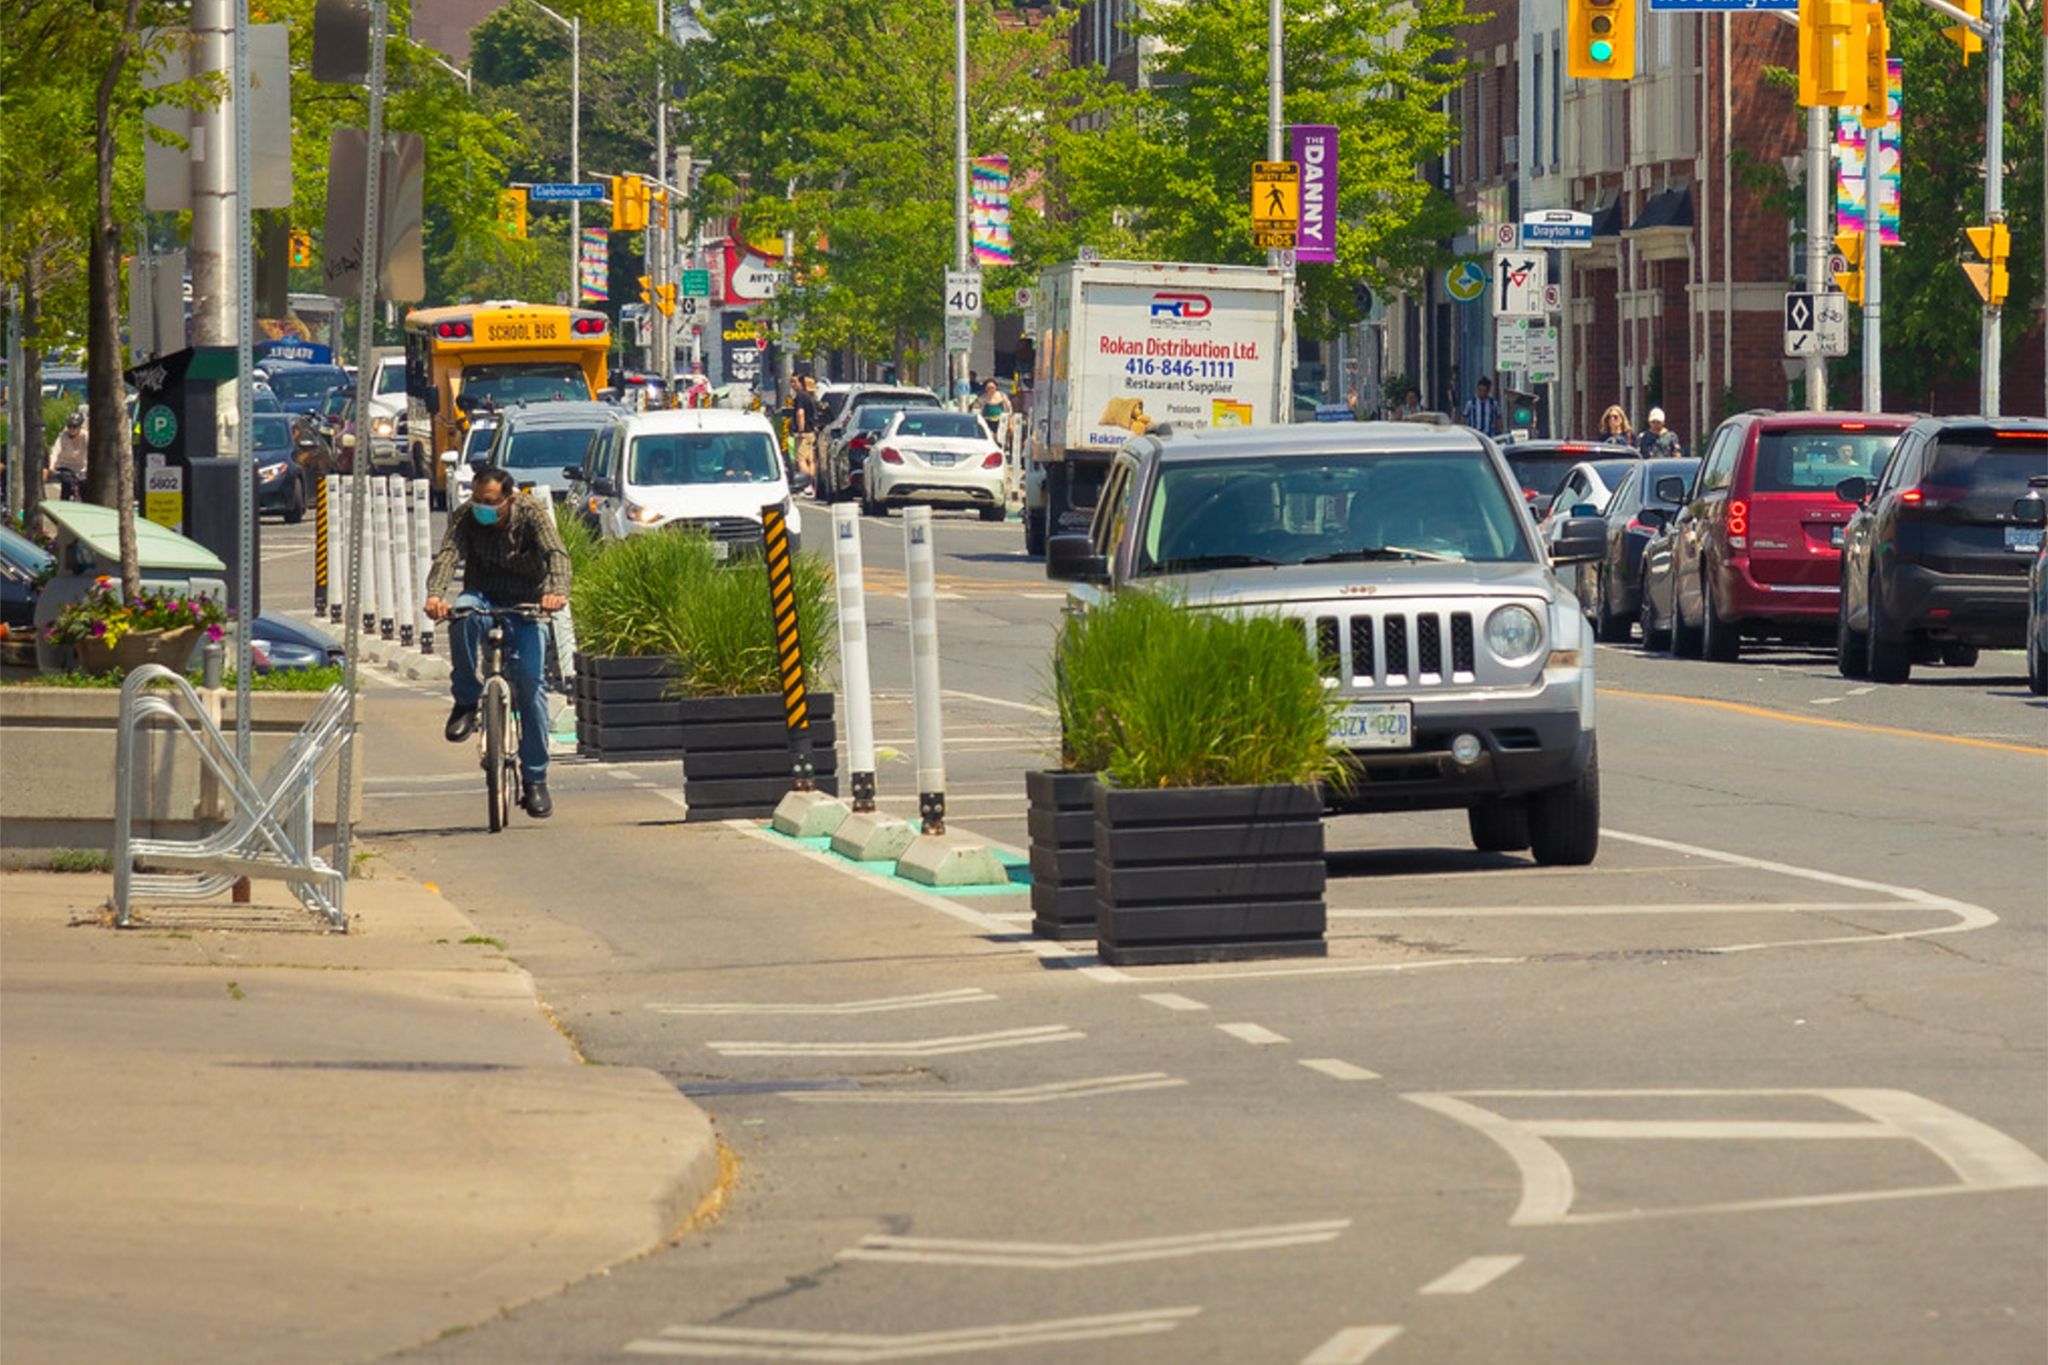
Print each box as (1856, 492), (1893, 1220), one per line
(1657, 411), (1913, 663)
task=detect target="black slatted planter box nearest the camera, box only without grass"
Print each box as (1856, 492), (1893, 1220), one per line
(1089, 784), (1329, 966)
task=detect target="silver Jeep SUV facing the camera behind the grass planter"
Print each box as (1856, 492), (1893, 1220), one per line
(1047, 422), (1606, 864)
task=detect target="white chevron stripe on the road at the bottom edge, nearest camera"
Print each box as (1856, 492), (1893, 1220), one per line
(623, 1306), (1202, 1365)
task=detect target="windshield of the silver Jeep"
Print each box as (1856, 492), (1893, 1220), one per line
(1139, 450), (1530, 575)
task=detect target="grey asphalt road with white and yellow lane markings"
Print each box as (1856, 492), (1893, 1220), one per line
(266, 510), (2048, 1365)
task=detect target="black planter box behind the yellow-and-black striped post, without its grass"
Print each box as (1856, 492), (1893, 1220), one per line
(676, 692), (840, 821)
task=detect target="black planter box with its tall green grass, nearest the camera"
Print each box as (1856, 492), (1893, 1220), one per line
(1055, 591), (1346, 964)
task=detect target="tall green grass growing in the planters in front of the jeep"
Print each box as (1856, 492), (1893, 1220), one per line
(1053, 591), (1346, 788)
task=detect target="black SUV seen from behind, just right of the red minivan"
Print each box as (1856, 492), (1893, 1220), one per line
(1835, 417), (2048, 684)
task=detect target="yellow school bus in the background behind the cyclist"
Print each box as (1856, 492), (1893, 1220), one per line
(406, 301), (612, 493)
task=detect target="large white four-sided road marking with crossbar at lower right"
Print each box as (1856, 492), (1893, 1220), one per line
(1403, 1087), (2048, 1228)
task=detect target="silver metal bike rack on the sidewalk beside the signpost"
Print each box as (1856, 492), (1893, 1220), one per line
(113, 663), (350, 933)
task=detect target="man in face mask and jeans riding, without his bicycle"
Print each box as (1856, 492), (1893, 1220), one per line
(426, 467), (569, 821)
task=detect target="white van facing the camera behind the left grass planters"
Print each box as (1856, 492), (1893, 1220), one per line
(571, 407), (803, 548)
